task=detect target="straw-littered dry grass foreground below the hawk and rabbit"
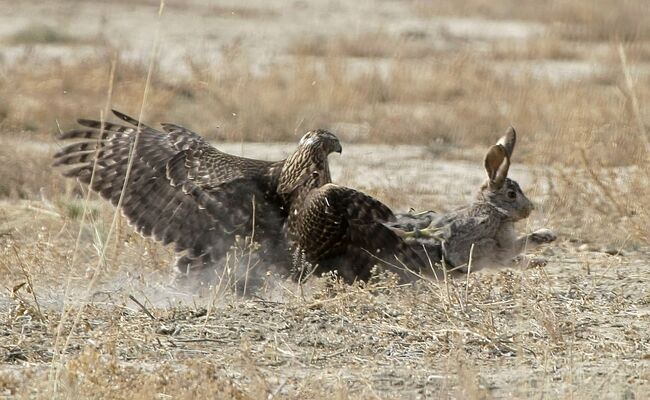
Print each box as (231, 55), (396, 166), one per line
(0, 202), (650, 399)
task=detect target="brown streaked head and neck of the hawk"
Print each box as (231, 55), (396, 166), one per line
(278, 129), (343, 195)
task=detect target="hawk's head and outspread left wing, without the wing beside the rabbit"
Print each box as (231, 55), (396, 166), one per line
(54, 110), (341, 273)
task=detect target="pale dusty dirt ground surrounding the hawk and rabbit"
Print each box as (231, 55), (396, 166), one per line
(0, 0), (650, 399)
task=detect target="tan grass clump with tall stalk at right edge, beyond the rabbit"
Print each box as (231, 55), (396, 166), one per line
(554, 45), (650, 248)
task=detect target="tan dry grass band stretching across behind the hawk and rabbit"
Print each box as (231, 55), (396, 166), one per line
(0, 47), (650, 161)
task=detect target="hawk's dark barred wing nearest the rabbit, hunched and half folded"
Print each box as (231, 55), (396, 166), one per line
(289, 184), (425, 281)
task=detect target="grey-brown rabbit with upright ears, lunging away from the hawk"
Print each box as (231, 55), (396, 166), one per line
(392, 127), (556, 272)
